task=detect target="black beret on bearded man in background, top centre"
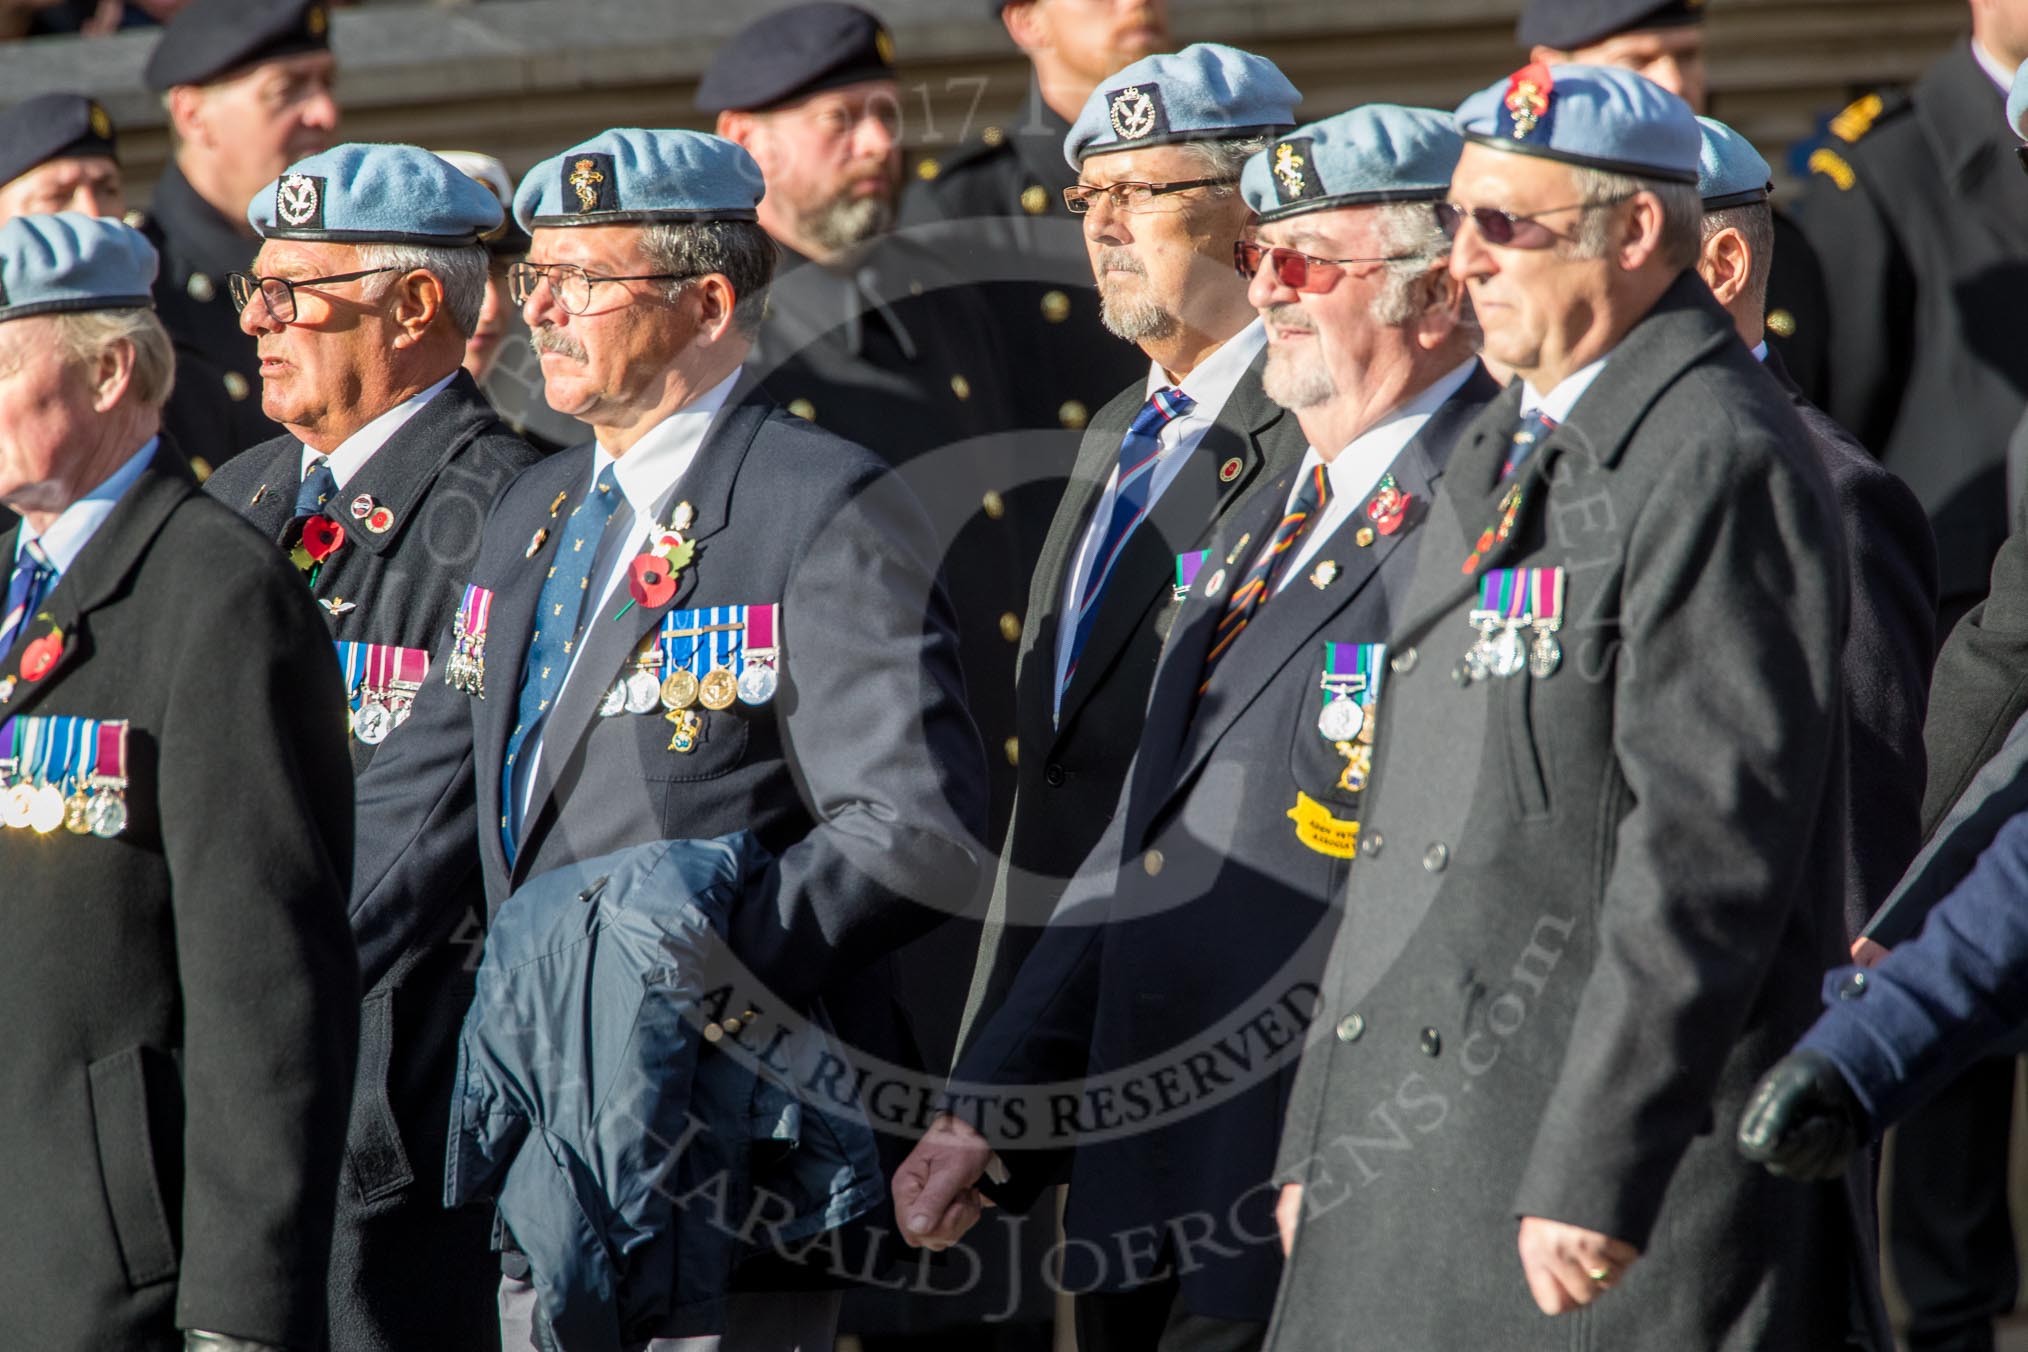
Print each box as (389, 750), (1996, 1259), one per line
(698, 0), (894, 114)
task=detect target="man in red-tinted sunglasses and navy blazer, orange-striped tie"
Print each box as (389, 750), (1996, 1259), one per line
(902, 105), (1497, 1352)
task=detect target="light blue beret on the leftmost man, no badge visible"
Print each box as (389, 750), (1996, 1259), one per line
(0, 211), (156, 320)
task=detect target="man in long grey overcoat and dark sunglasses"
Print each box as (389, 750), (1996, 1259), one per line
(1268, 65), (1862, 1352)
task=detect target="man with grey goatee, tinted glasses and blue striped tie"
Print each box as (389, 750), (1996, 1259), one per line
(967, 43), (1304, 1070)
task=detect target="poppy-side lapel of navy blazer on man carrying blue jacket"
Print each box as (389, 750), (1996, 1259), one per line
(513, 387), (775, 882)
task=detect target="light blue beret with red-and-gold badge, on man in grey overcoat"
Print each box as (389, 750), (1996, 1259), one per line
(1458, 61), (1704, 182)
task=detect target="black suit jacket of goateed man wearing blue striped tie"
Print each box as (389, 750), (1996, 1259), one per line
(965, 351), (1308, 1038)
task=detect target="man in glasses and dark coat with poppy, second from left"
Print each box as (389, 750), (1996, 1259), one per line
(205, 144), (537, 1352)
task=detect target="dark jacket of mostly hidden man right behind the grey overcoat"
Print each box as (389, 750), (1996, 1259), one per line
(1762, 351), (1937, 936)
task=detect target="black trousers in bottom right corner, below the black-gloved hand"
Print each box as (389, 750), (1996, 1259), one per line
(1888, 1056), (2020, 1352)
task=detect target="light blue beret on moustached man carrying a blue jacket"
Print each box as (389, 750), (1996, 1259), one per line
(513, 128), (767, 231)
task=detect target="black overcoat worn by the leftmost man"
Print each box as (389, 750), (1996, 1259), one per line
(0, 458), (359, 1352)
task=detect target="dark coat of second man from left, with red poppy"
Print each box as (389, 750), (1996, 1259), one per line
(205, 371), (539, 1352)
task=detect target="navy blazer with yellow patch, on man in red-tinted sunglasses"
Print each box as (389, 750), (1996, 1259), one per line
(955, 369), (1499, 1320)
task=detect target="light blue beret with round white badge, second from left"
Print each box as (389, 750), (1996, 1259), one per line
(247, 142), (501, 247)
